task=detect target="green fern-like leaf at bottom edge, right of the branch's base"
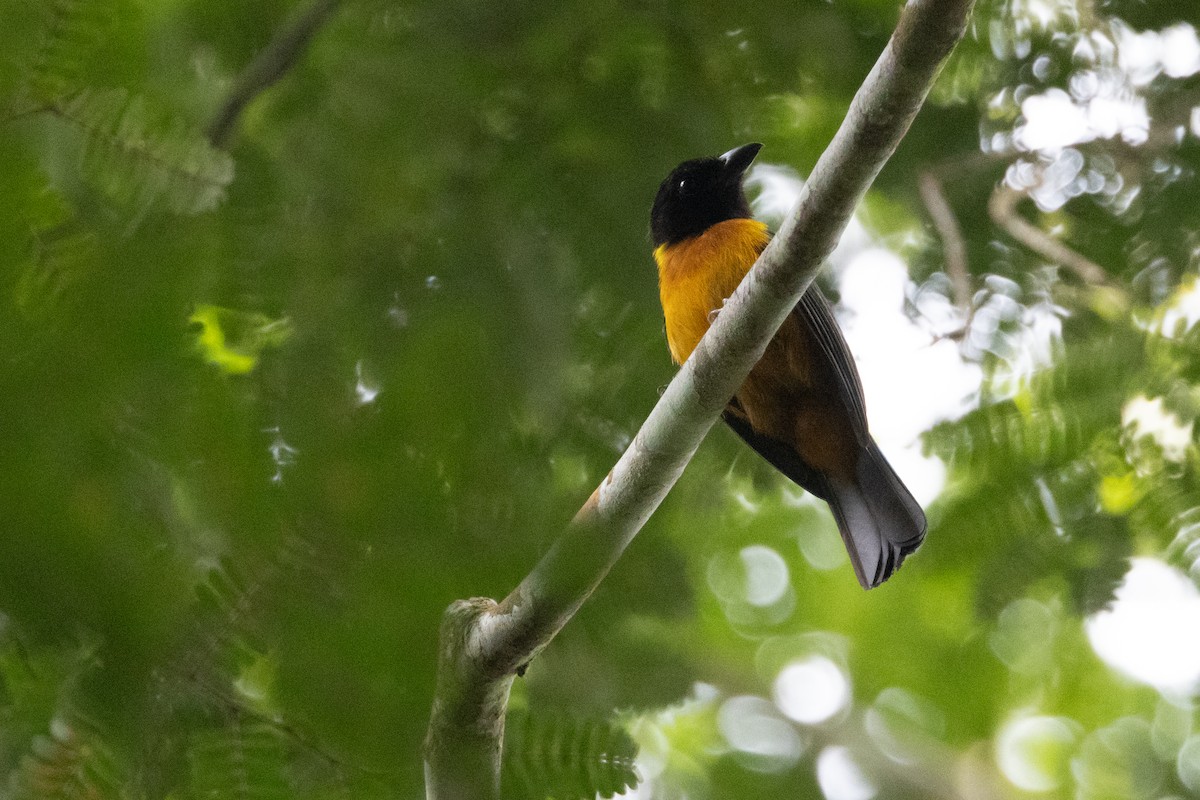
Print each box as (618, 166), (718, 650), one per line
(502, 710), (637, 800)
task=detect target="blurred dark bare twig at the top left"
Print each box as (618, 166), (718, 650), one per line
(208, 0), (341, 148)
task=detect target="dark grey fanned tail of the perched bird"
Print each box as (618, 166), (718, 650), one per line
(826, 441), (925, 589)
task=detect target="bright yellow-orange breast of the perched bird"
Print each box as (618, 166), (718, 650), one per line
(654, 219), (770, 363)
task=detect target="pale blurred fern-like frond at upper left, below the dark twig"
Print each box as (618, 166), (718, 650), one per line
(49, 89), (233, 213)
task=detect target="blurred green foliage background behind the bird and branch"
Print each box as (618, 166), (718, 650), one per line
(0, 0), (1200, 800)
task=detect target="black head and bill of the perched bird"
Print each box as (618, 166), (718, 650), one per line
(650, 142), (762, 247)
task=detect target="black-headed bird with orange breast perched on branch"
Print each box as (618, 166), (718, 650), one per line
(650, 143), (926, 589)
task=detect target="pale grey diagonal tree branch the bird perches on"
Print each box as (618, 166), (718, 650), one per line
(425, 0), (973, 800)
